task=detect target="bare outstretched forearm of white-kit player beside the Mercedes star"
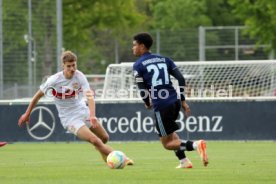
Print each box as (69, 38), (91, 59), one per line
(18, 89), (44, 126)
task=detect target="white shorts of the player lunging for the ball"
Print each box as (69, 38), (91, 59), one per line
(60, 108), (92, 135)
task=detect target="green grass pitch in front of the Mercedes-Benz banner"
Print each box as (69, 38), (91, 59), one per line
(0, 141), (276, 184)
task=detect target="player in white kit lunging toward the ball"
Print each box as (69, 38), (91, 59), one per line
(18, 51), (133, 165)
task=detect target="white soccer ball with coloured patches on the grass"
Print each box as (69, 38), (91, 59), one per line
(106, 151), (126, 169)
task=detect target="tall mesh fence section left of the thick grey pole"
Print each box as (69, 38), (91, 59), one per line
(0, 0), (61, 99)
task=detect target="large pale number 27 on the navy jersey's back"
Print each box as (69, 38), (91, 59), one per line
(147, 63), (170, 86)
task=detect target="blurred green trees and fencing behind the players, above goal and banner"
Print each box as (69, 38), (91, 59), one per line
(0, 0), (276, 99)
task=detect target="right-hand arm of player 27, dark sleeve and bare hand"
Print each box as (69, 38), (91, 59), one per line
(171, 68), (191, 117)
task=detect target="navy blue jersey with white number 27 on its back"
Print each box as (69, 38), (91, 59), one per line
(133, 52), (178, 110)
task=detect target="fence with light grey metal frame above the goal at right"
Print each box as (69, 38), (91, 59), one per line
(199, 26), (274, 61)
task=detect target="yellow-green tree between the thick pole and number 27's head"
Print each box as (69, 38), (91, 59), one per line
(63, 0), (146, 73)
